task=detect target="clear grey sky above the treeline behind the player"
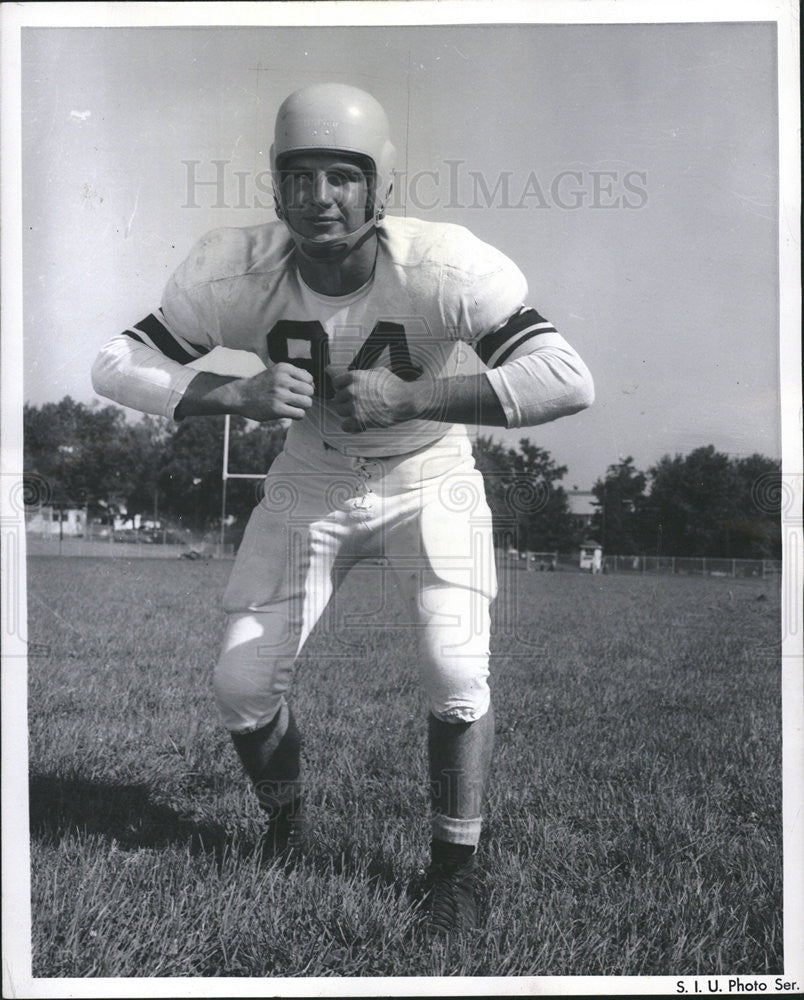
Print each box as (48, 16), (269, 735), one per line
(22, 14), (781, 489)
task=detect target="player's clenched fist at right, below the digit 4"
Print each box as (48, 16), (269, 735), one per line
(327, 368), (416, 431)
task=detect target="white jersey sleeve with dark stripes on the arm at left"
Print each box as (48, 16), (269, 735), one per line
(92, 231), (231, 417)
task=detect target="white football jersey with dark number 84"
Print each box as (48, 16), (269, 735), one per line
(91, 218), (557, 456)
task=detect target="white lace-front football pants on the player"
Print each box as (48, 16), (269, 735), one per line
(215, 420), (497, 732)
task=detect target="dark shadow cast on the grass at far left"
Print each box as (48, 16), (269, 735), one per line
(29, 774), (256, 863)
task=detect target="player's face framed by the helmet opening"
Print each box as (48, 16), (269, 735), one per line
(281, 151), (370, 242)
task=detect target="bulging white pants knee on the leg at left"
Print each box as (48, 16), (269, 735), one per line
(213, 611), (298, 732)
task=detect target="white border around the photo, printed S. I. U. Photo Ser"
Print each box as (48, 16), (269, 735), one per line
(0, 0), (804, 997)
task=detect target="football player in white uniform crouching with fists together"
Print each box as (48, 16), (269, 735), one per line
(93, 83), (593, 934)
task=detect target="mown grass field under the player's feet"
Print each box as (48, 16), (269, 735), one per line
(28, 558), (782, 977)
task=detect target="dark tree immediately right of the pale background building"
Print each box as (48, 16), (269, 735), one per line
(592, 455), (647, 555)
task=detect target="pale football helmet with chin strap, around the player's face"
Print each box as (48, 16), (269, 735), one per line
(271, 83), (396, 261)
